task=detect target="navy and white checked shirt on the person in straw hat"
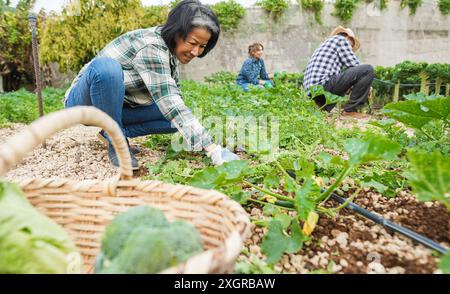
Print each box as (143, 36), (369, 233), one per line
(303, 35), (360, 90)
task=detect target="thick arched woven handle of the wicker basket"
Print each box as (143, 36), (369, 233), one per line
(0, 106), (133, 180)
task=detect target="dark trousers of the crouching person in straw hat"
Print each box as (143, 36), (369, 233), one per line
(314, 64), (375, 112)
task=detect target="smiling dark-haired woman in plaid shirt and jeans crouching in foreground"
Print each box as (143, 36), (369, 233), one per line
(65, 0), (239, 169)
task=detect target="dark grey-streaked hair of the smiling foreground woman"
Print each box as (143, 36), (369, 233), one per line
(161, 0), (220, 57)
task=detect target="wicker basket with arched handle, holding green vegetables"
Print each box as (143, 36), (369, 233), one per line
(0, 106), (250, 273)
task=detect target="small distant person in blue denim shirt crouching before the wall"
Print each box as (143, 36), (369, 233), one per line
(236, 43), (273, 92)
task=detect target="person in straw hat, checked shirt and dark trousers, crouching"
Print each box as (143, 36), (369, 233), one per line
(303, 26), (375, 118)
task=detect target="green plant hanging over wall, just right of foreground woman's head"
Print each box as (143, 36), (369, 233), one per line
(211, 0), (245, 31)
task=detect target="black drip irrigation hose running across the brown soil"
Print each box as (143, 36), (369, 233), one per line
(287, 170), (448, 254)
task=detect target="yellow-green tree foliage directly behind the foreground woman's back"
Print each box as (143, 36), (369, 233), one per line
(40, 0), (168, 72)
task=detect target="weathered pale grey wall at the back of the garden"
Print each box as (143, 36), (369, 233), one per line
(181, 0), (450, 81)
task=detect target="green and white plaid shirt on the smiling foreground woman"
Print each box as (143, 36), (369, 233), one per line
(65, 27), (212, 150)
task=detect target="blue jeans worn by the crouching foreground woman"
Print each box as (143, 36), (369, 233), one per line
(65, 57), (178, 140)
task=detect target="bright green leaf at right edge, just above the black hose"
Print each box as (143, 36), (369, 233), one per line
(406, 150), (450, 210)
